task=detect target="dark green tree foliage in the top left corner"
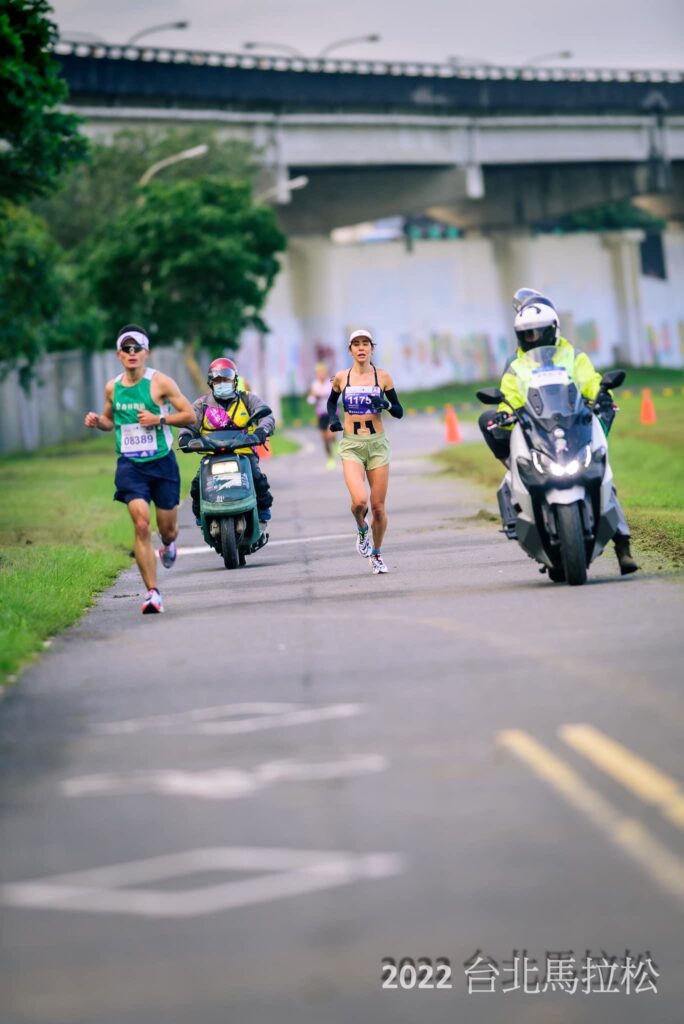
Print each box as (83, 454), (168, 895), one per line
(0, 0), (87, 202)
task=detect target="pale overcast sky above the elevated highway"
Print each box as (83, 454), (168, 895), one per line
(52, 0), (684, 70)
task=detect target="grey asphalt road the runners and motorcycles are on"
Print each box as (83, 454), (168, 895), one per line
(0, 418), (684, 1024)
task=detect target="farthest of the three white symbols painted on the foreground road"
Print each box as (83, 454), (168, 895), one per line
(94, 703), (366, 736)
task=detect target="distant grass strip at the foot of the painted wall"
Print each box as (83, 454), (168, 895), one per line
(282, 365), (684, 426)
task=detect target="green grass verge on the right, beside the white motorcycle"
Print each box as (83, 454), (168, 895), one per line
(437, 384), (684, 567)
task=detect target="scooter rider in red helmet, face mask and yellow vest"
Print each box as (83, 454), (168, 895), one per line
(183, 357), (275, 531)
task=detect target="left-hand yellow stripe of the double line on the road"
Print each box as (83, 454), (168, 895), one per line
(497, 729), (684, 905)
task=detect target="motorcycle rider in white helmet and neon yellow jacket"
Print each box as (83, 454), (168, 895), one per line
(478, 288), (639, 575)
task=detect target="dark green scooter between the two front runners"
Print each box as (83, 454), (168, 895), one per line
(178, 406), (270, 569)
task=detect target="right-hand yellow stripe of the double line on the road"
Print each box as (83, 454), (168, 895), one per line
(558, 725), (684, 828)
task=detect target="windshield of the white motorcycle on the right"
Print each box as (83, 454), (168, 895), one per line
(518, 345), (591, 461)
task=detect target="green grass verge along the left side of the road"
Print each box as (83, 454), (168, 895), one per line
(0, 434), (298, 683)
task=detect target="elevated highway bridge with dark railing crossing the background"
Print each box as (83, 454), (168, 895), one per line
(56, 42), (684, 234)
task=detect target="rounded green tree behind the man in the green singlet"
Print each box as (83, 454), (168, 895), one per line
(85, 177), (285, 379)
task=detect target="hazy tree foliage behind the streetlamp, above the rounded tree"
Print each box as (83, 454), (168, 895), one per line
(30, 126), (258, 252)
